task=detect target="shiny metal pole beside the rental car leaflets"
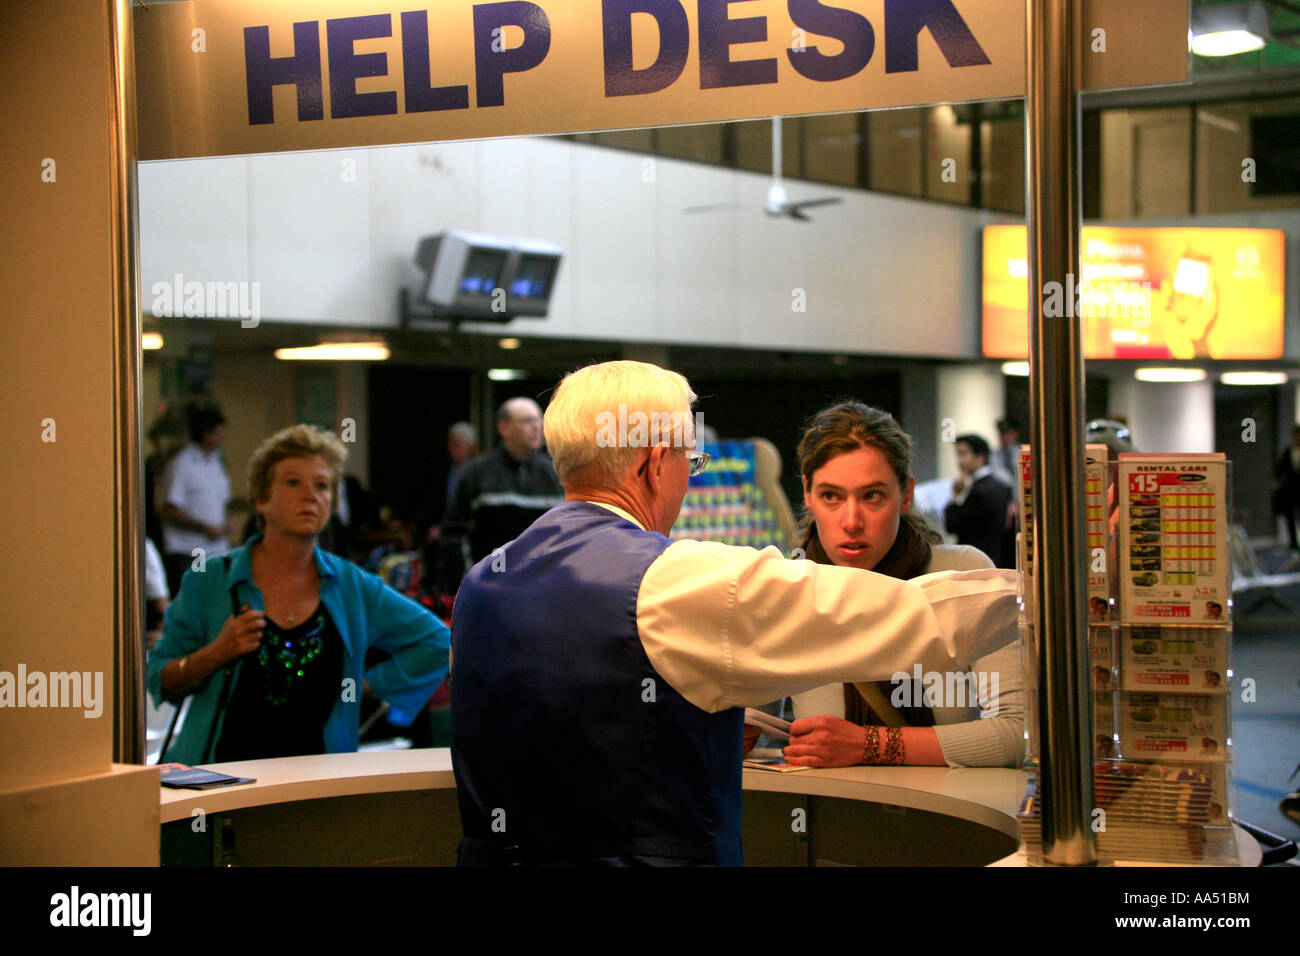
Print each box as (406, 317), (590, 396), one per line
(1024, 0), (1097, 865)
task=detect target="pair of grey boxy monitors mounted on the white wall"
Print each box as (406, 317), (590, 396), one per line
(415, 229), (564, 321)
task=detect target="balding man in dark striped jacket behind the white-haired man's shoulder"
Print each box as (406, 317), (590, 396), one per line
(438, 398), (564, 594)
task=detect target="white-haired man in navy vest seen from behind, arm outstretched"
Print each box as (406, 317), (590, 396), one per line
(451, 362), (1017, 865)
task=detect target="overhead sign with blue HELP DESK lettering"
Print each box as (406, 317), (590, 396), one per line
(134, 0), (1187, 160)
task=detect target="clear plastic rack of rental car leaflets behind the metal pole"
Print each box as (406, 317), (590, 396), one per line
(1019, 446), (1238, 865)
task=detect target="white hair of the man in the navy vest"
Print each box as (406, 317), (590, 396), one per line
(543, 360), (696, 488)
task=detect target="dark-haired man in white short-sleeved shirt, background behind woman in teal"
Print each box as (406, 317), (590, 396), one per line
(161, 408), (230, 594)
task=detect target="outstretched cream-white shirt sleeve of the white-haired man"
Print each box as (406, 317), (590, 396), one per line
(637, 541), (1017, 711)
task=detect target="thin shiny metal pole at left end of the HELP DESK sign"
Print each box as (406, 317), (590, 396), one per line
(107, 0), (146, 763)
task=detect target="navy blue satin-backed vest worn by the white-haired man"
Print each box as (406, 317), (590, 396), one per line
(451, 501), (744, 866)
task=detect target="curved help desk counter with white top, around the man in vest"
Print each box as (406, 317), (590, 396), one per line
(152, 748), (1260, 866)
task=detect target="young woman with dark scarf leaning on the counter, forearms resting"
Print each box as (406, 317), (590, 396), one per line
(785, 402), (1024, 767)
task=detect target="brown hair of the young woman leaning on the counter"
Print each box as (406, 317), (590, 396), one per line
(794, 401), (943, 564)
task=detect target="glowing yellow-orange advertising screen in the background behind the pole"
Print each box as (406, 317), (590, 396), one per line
(984, 226), (1286, 359)
